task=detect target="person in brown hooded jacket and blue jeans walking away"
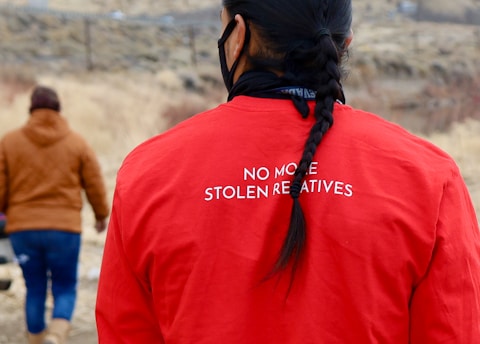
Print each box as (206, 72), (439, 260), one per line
(0, 86), (110, 344)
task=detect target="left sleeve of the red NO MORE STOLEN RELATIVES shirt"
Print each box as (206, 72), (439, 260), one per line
(96, 188), (164, 344)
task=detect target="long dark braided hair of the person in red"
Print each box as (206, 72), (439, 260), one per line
(223, 0), (352, 286)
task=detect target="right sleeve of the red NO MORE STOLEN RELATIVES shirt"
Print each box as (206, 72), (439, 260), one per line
(410, 170), (480, 344)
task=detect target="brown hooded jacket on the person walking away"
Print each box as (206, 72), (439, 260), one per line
(0, 108), (109, 233)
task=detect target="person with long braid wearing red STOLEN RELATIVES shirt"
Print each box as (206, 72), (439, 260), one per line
(96, 0), (480, 344)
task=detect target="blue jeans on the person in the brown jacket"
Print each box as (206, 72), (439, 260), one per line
(10, 230), (81, 333)
